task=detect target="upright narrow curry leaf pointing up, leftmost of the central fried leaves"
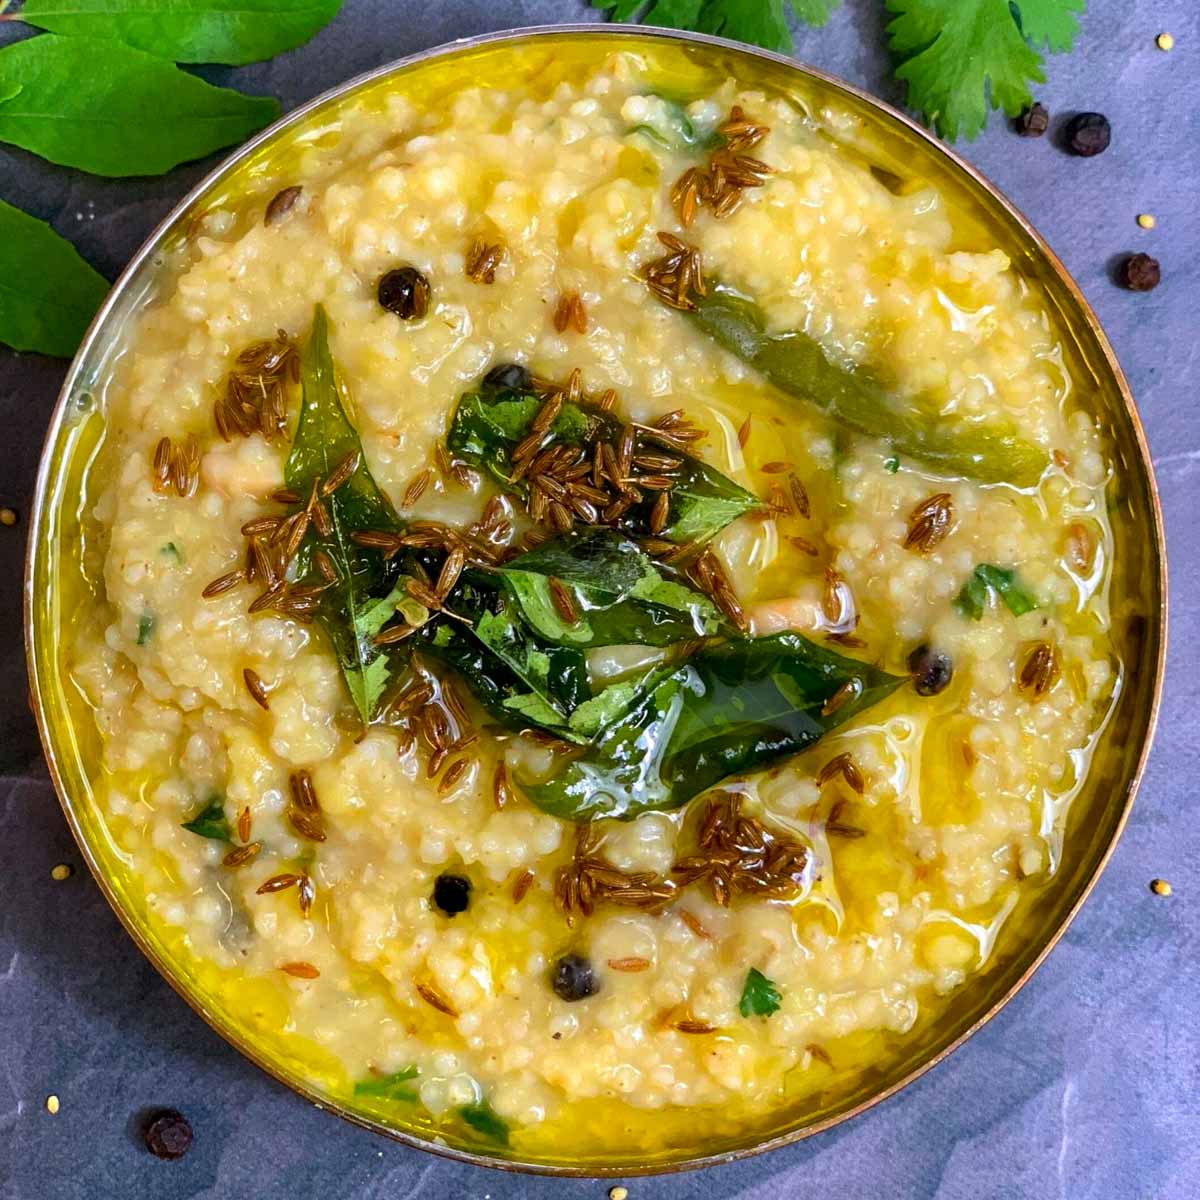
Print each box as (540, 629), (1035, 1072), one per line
(284, 305), (402, 721)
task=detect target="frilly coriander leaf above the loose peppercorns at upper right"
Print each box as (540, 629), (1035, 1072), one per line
(887, 0), (1084, 139)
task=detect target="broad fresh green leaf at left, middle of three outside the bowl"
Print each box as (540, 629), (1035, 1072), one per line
(0, 34), (280, 176)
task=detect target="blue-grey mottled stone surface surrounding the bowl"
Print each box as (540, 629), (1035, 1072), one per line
(0, 0), (1200, 1200)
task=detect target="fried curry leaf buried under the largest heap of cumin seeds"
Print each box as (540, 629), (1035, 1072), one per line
(446, 379), (761, 542)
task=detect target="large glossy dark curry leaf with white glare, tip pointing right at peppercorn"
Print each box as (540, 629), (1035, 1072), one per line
(523, 634), (904, 821)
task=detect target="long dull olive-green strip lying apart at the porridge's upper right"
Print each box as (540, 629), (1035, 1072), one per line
(689, 283), (1046, 487)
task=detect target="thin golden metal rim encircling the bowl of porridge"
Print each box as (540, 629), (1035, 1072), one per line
(23, 22), (1168, 1178)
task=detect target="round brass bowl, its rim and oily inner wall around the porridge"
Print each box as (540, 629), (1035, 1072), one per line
(25, 25), (1166, 1175)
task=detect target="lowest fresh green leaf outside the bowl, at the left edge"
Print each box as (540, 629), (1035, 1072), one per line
(0, 196), (108, 359)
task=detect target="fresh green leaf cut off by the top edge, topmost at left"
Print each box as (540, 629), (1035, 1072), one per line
(17, 0), (341, 66)
